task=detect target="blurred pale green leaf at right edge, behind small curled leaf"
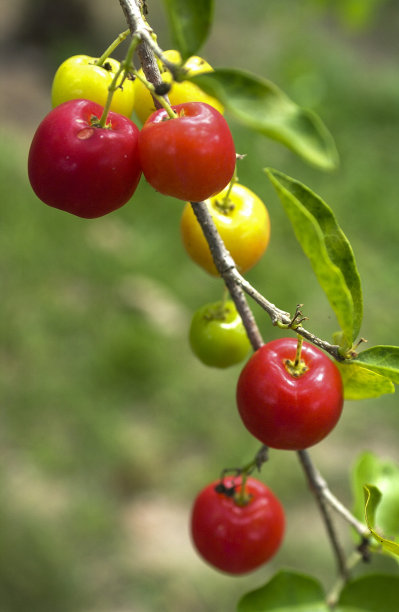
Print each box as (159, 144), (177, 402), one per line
(352, 452), (399, 538)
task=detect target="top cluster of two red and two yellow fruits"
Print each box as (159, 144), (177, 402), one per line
(28, 51), (236, 218)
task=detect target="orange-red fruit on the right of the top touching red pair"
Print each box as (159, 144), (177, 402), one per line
(139, 102), (236, 202)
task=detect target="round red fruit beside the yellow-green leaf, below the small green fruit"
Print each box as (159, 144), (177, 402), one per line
(237, 338), (343, 450)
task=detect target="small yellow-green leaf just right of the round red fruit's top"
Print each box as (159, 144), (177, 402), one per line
(336, 363), (395, 400)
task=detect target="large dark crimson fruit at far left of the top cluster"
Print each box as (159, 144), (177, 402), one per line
(28, 100), (141, 219)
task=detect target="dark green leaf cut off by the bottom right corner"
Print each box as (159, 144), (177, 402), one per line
(334, 574), (399, 612)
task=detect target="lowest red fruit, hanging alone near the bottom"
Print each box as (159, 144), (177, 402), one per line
(191, 477), (285, 574)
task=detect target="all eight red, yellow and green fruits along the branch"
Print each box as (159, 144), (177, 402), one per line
(28, 44), (343, 574)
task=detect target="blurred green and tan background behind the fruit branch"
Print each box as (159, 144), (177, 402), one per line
(0, 0), (399, 612)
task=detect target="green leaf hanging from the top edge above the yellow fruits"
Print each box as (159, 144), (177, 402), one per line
(164, 0), (214, 61)
